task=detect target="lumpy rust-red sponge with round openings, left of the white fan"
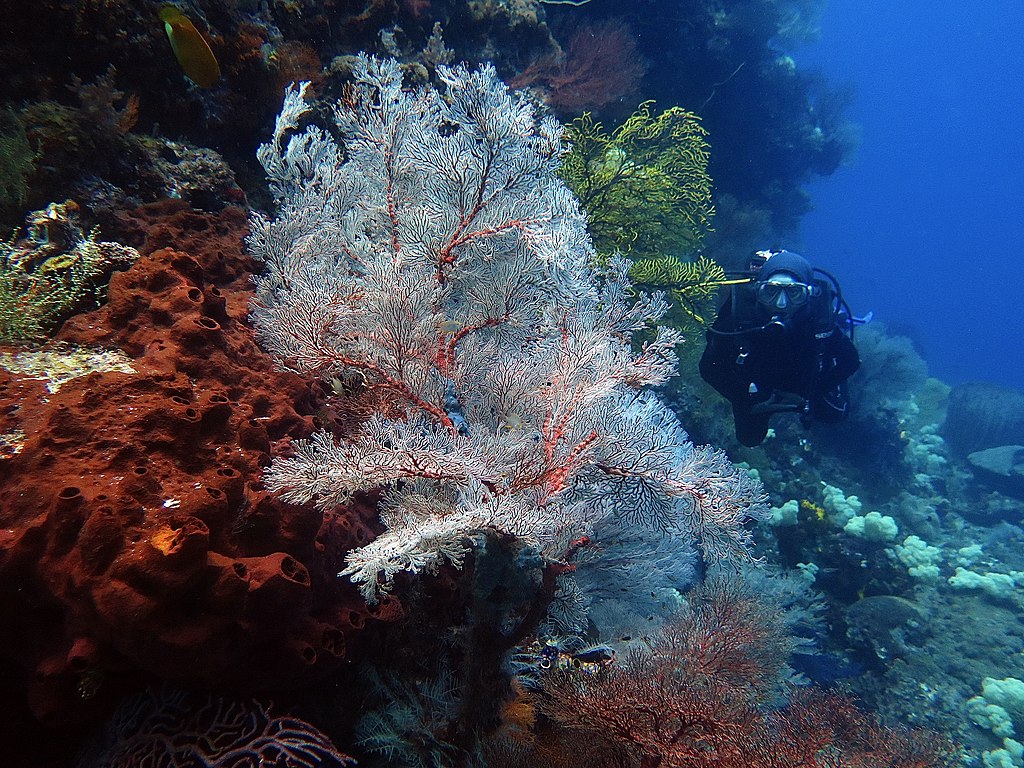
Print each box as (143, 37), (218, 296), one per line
(0, 204), (400, 721)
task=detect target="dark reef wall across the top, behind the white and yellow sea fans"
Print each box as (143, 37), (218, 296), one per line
(0, 0), (852, 252)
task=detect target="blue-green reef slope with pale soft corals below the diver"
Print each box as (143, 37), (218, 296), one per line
(704, 368), (1024, 766)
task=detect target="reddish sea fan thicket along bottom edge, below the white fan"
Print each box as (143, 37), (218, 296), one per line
(530, 583), (957, 768)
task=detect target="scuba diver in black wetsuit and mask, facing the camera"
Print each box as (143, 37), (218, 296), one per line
(700, 251), (865, 446)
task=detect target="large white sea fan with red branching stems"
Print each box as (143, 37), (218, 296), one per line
(248, 56), (764, 600)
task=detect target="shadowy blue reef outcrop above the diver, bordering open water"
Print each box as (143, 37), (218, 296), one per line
(547, 0), (855, 236)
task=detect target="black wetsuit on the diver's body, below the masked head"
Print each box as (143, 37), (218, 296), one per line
(700, 298), (860, 446)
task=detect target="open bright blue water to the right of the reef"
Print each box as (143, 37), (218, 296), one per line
(797, 0), (1024, 388)
